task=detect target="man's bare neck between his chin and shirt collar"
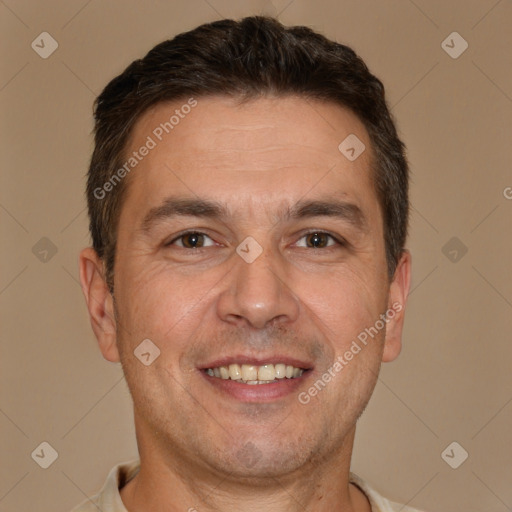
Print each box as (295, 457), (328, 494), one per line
(120, 420), (371, 512)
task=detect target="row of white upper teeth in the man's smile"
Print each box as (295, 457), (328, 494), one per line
(206, 363), (304, 384)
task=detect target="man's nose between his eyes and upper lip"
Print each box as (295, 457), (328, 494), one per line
(217, 242), (300, 329)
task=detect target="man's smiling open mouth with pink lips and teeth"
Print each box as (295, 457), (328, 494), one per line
(200, 357), (312, 403)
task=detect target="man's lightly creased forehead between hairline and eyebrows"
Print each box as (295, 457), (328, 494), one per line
(118, 97), (378, 224)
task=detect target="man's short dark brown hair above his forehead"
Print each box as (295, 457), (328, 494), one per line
(87, 16), (409, 291)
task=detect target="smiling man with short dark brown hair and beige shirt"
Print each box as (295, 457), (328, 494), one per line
(75, 17), (420, 512)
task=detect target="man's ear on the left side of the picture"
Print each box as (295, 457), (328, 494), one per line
(79, 247), (120, 363)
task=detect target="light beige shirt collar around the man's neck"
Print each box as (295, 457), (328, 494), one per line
(71, 459), (420, 512)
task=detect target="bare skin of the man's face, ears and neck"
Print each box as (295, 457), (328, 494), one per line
(80, 97), (411, 512)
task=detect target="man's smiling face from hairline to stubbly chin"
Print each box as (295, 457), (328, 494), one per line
(86, 97), (410, 476)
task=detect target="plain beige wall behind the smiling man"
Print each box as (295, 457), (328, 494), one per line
(0, 0), (512, 512)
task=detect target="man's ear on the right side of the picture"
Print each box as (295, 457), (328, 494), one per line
(382, 250), (411, 363)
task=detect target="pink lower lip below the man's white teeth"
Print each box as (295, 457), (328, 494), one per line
(201, 370), (310, 403)
